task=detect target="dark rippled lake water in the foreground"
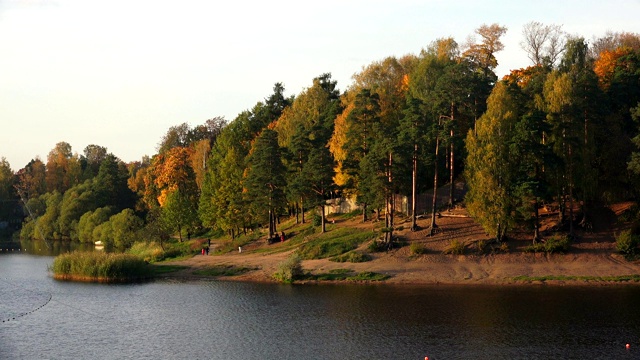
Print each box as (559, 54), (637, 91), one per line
(0, 251), (640, 360)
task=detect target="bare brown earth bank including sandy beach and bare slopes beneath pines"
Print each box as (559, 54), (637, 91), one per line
(161, 205), (640, 285)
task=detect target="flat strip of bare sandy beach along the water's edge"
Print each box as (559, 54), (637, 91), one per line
(159, 249), (640, 286)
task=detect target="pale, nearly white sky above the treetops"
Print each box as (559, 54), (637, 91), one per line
(0, 0), (640, 171)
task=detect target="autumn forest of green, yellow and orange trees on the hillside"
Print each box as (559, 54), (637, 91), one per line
(0, 22), (640, 248)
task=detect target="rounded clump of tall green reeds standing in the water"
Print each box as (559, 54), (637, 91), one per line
(49, 251), (150, 282)
